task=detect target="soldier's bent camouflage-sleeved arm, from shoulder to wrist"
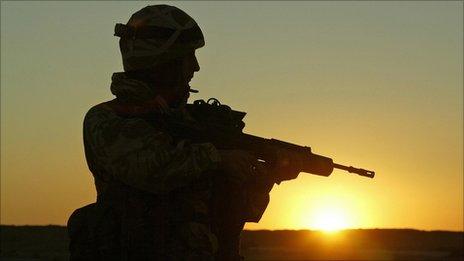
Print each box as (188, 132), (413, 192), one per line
(84, 107), (220, 193)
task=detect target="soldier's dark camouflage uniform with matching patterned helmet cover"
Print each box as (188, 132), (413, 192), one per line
(68, 5), (272, 260)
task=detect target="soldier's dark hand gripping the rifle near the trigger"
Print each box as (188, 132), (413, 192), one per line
(219, 150), (259, 183)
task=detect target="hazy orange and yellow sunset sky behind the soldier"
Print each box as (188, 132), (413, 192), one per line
(1, 1), (464, 231)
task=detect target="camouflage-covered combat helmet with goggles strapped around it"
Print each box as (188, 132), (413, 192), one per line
(114, 5), (205, 72)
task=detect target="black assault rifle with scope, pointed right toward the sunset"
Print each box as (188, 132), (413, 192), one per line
(167, 98), (375, 178)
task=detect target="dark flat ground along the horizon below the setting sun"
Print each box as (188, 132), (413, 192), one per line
(0, 226), (464, 261)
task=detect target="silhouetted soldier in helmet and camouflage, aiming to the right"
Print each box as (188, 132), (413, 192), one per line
(68, 5), (298, 260)
